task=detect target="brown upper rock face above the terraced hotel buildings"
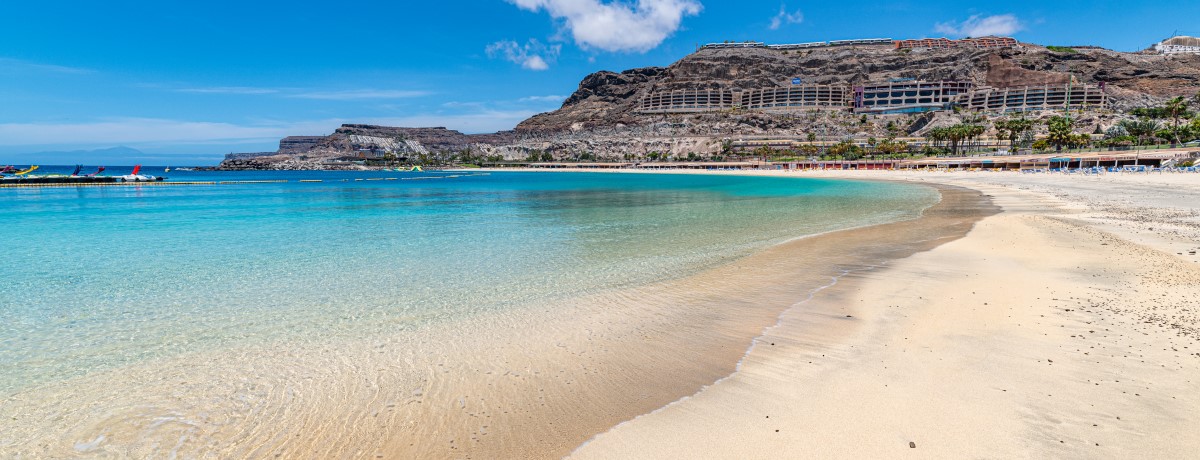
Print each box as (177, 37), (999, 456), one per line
(516, 44), (1200, 133)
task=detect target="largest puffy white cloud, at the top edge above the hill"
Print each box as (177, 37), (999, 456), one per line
(509, 0), (703, 53)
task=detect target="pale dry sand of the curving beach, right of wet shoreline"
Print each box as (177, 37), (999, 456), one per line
(572, 172), (1200, 459)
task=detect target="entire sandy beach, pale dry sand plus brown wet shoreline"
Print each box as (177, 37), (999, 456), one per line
(0, 171), (1200, 459)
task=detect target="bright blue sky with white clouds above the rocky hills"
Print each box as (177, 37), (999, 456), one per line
(0, 0), (1200, 165)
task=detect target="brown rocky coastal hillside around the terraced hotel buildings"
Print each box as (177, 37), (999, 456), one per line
(221, 43), (1200, 168)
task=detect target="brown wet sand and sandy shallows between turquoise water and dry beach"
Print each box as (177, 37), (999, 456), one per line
(0, 180), (995, 458)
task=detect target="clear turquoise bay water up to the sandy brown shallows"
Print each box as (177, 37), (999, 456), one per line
(0, 169), (937, 395)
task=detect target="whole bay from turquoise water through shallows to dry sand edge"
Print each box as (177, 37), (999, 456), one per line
(0, 173), (955, 458)
